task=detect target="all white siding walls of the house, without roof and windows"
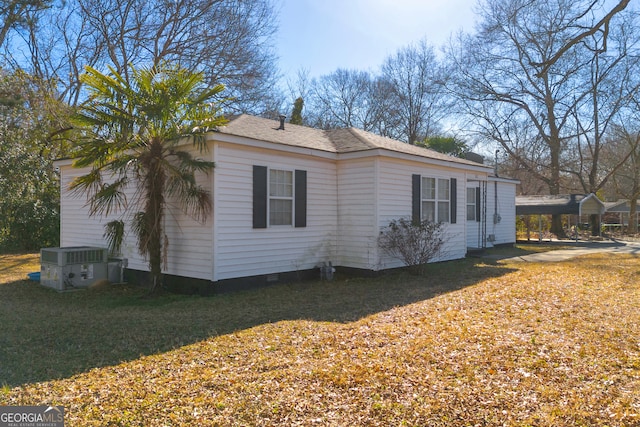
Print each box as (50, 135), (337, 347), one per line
(61, 140), (515, 281)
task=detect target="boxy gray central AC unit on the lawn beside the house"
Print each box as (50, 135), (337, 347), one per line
(40, 246), (108, 291)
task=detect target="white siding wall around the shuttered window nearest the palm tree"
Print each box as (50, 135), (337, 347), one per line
(211, 142), (338, 281)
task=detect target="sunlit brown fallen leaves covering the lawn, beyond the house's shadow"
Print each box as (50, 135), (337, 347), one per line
(0, 255), (640, 426)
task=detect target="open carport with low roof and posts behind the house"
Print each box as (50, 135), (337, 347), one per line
(516, 193), (605, 241)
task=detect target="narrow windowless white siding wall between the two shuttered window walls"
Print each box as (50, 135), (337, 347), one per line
(337, 157), (378, 270)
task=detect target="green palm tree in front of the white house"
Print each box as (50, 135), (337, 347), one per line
(71, 63), (225, 293)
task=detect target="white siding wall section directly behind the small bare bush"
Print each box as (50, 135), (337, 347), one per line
(378, 159), (467, 269)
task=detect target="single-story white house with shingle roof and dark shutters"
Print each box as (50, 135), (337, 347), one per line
(57, 115), (517, 287)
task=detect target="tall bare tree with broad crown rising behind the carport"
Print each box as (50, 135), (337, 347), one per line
(449, 0), (638, 235)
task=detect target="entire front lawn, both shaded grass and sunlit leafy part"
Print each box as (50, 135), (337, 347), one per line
(0, 247), (640, 426)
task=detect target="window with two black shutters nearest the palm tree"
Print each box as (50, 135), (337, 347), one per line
(253, 166), (307, 228)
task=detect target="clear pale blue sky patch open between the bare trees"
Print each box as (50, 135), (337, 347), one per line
(276, 0), (476, 77)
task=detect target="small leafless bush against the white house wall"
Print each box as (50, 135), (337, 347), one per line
(378, 218), (444, 275)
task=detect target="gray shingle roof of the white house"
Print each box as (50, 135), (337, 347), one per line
(217, 114), (488, 168)
